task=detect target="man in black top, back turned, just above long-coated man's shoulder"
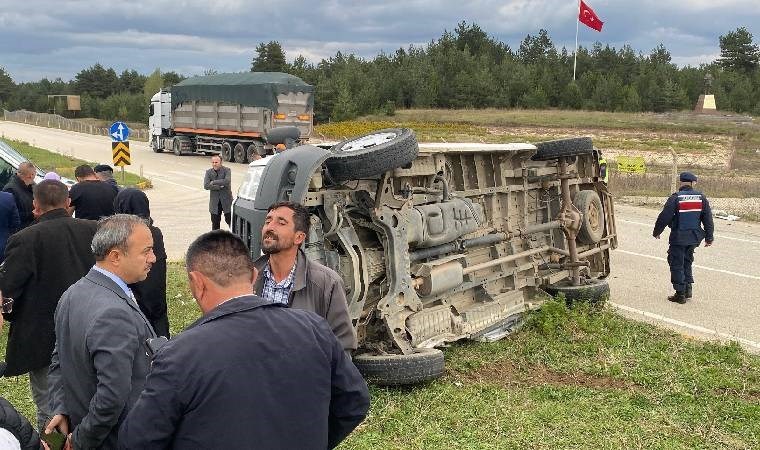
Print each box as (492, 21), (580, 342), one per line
(69, 164), (116, 220)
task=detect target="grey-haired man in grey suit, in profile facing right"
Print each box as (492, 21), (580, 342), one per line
(45, 214), (156, 449)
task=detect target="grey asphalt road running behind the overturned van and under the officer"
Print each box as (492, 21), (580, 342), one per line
(0, 121), (760, 353)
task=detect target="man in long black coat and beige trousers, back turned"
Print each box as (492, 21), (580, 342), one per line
(0, 180), (97, 429)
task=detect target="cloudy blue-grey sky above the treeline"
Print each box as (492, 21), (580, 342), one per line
(0, 0), (760, 82)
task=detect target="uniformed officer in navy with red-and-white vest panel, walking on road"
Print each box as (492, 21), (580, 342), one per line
(652, 172), (713, 304)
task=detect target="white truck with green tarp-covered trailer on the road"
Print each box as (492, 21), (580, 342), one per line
(148, 72), (314, 163)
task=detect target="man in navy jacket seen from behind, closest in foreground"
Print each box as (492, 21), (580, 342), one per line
(119, 231), (369, 450)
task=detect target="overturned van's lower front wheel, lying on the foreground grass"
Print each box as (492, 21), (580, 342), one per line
(354, 348), (444, 386)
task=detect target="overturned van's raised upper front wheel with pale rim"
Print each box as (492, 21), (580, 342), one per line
(325, 128), (419, 182)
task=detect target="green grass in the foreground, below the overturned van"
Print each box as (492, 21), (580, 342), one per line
(0, 263), (760, 450)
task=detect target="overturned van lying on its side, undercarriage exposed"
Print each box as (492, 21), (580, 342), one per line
(232, 128), (617, 385)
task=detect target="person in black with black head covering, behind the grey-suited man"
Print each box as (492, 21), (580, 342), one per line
(114, 188), (169, 338)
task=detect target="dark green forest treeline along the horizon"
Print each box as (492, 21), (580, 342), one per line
(0, 22), (760, 122)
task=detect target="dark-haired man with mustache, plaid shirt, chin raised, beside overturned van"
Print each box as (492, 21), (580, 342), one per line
(254, 202), (357, 352)
